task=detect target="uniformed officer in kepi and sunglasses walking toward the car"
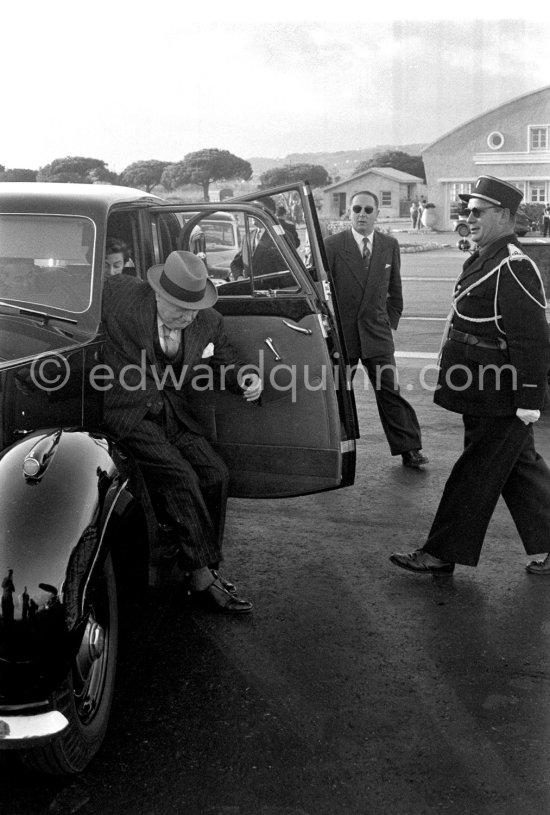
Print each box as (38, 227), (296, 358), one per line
(390, 176), (550, 575)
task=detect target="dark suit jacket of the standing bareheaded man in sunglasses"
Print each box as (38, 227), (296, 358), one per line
(325, 229), (403, 359)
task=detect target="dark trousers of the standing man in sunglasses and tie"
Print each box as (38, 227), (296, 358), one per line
(350, 354), (422, 456)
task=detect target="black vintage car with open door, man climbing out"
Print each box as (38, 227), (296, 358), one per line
(0, 182), (357, 773)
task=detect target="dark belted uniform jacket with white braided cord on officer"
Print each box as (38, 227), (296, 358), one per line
(434, 235), (550, 416)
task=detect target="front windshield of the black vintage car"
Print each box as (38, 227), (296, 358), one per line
(0, 214), (95, 313)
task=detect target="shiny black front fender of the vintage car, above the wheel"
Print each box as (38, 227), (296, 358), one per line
(0, 429), (148, 704)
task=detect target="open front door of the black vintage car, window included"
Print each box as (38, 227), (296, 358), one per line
(150, 183), (358, 498)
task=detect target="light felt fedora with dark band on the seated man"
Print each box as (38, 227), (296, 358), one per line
(147, 251), (218, 310)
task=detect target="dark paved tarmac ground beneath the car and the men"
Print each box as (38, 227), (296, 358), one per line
(0, 237), (550, 815)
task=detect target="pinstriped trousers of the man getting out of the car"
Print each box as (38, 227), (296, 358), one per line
(122, 406), (229, 571)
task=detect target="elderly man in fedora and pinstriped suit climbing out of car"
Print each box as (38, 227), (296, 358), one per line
(102, 251), (262, 614)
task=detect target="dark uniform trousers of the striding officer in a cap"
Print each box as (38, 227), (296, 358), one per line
(423, 416), (550, 566)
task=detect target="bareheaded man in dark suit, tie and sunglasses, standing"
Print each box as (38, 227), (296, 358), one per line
(325, 191), (428, 469)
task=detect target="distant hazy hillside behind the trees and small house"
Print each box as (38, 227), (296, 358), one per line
(247, 143), (427, 178)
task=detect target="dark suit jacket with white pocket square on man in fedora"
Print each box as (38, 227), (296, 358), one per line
(102, 275), (243, 438)
